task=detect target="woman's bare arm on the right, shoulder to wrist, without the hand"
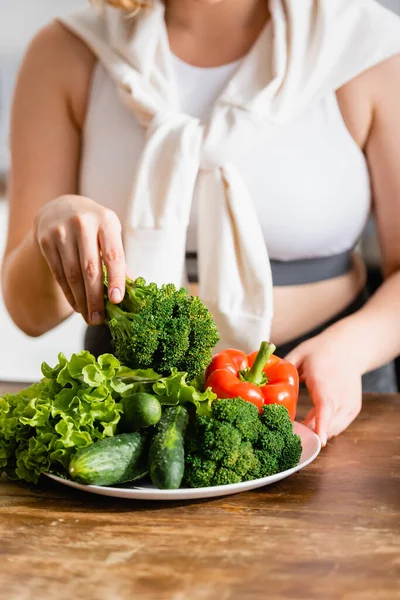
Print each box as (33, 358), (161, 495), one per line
(326, 56), (400, 373)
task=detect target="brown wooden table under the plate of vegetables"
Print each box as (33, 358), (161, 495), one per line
(0, 387), (400, 600)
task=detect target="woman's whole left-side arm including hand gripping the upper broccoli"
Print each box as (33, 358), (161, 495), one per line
(2, 23), (125, 336)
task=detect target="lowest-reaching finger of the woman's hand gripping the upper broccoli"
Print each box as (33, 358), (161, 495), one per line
(78, 223), (104, 325)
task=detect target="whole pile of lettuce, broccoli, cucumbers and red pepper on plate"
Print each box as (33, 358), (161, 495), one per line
(0, 279), (302, 489)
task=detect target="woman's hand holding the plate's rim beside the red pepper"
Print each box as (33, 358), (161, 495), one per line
(286, 328), (362, 446)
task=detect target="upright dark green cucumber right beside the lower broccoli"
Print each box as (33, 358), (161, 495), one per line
(149, 406), (189, 490)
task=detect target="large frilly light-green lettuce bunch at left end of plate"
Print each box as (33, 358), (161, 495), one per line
(0, 352), (122, 483)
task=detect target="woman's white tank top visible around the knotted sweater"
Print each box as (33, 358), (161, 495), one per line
(80, 57), (371, 261)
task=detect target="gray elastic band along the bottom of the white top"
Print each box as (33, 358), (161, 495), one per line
(186, 250), (353, 286)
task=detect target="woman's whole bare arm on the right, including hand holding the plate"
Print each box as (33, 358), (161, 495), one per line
(287, 56), (400, 444)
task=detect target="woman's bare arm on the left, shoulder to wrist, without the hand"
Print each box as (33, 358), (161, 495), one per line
(2, 24), (92, 335)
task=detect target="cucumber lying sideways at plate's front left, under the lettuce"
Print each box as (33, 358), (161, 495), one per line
(69, 431), (148, 485)
